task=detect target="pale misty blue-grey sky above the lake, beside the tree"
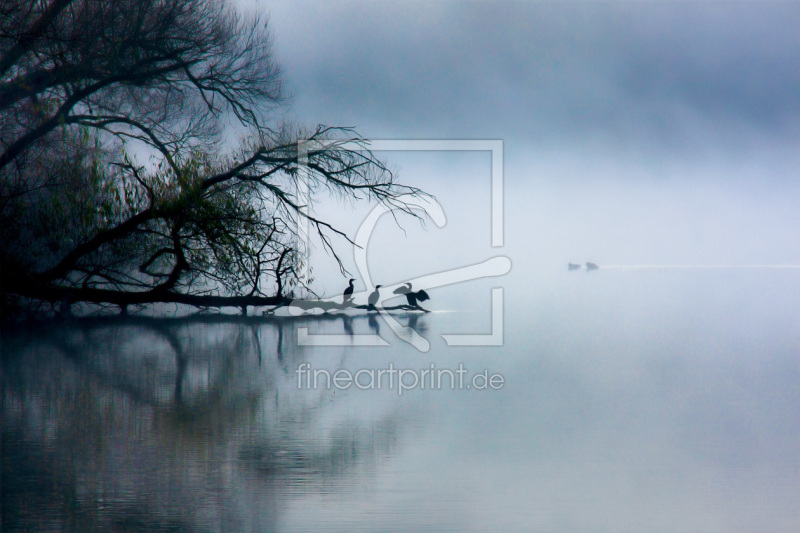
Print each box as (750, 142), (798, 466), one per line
(241, 1), (800, 296)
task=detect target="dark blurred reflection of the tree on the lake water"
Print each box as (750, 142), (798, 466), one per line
(2, 319), (403, 531)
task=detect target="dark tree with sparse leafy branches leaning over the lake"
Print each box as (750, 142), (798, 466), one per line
(0, 0), (423, 316)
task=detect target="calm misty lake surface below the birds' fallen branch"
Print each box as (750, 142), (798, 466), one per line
(1, 270), (800, 533)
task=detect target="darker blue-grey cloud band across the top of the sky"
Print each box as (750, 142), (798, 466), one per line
(264, 1), (800, 155)
